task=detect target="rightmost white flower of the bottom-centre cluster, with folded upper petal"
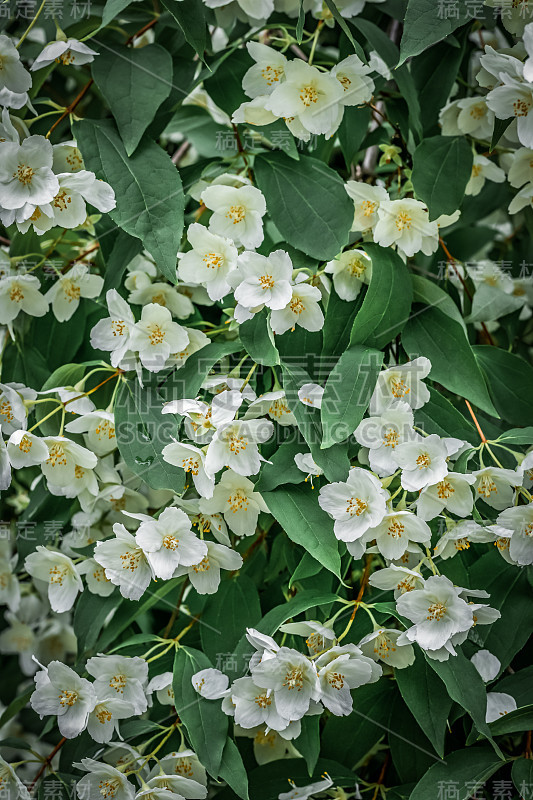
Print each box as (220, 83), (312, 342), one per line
(316, 644), (381, 717)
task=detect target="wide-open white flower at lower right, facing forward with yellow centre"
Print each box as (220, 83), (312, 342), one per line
(396, 575), (474, 650)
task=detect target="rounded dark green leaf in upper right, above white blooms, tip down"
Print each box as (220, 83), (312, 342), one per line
(411, 136), (474, 220)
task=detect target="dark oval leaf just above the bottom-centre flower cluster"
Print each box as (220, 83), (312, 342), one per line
(200, 574), (261, 664)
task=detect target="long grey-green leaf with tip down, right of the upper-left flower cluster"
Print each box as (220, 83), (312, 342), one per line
(74, 120), (184, 283)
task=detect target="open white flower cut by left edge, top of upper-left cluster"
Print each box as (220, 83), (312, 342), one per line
(0, 136), (59, 209)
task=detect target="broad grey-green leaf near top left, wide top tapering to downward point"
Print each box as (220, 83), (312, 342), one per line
(92, 42), (172, 156)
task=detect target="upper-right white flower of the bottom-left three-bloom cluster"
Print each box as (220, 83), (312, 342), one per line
(85, 655), (148, 714)
